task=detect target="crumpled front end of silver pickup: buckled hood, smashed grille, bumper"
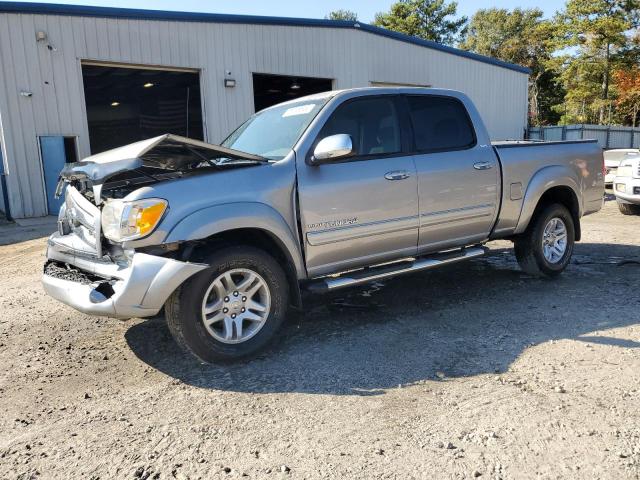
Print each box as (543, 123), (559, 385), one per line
(42, 135), (266, 318)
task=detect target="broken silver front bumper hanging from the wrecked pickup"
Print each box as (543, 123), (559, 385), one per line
(42, 233), (207, 318)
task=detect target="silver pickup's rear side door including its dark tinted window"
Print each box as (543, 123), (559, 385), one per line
(405, 95), (500, 253)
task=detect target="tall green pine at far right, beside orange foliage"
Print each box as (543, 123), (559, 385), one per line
(556, 0), (640, 124)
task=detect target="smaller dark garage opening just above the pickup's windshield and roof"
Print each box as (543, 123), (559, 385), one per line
(253, 73), (333, 112)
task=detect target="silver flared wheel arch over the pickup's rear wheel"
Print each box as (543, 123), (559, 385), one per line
(514, 165), (583, 234)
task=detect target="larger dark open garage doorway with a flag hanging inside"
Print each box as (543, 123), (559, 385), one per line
(82, 64), (204, 154)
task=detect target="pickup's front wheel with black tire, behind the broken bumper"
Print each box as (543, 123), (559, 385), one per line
(165, 246), (289, 363)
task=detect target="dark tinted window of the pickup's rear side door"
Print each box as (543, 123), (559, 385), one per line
(407, 95), (476, 152)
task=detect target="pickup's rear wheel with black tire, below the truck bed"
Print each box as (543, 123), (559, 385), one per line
(514, 204), (575, 277)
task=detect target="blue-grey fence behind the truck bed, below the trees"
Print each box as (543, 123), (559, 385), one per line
(528, 125), (640, 149)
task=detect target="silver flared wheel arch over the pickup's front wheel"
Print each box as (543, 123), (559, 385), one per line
(164, 202), (307, 279)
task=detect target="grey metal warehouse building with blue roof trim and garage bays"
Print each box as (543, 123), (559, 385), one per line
(0, 3), (528, 218)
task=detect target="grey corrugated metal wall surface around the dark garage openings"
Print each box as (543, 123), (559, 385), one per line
(0, 13), (527, 217)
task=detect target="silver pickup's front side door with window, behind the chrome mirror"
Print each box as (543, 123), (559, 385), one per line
(298, 96), (418, 276)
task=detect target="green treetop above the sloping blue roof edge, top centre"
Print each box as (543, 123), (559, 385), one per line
(373, 0), (467, 45)
